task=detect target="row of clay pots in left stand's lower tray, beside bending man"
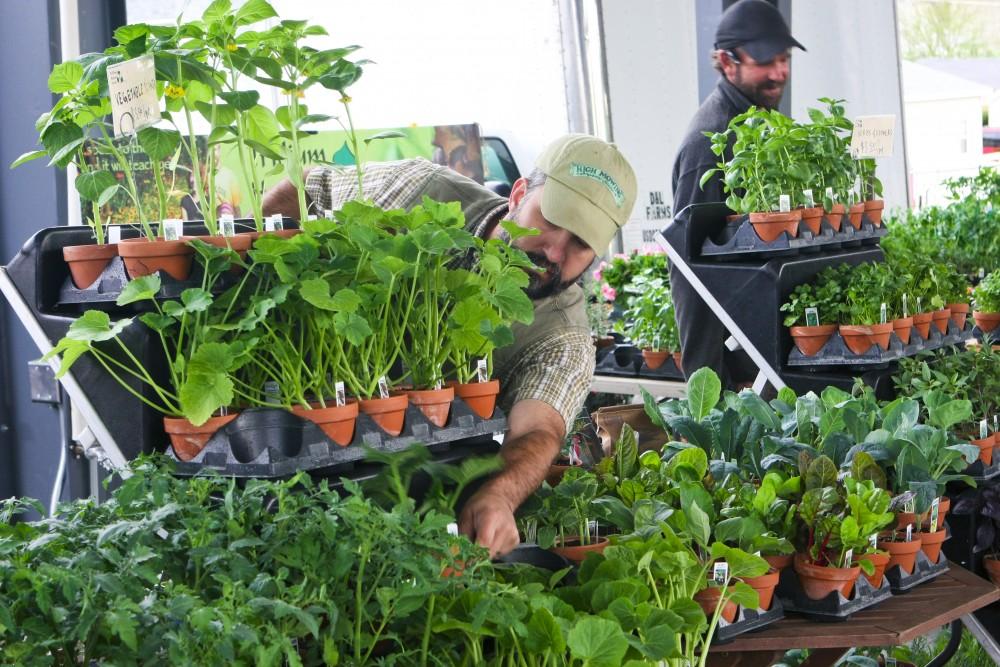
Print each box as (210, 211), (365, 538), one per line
(163, 380), (500, 461)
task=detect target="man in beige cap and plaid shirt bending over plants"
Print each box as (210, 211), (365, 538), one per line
(264, 134), (636, 556)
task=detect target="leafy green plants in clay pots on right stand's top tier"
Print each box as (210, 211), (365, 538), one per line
(701, 98), (882, 243)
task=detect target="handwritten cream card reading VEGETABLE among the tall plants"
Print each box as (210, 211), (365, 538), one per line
(108, 54), (160, 137)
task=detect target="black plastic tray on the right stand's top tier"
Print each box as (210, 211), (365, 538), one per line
(701, 216), (888, 261)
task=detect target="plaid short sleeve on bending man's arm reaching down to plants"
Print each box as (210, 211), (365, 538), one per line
(497, 328), (595, 433)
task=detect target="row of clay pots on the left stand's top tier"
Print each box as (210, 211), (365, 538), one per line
(62, 229), (300, 289)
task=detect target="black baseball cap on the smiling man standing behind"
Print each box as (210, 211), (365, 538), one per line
(715, 0), (806, 63)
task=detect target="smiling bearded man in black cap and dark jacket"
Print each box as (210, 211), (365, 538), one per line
(670, 0), (805, 389)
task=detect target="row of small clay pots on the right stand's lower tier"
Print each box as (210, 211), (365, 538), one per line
(788, 303), (969, 357)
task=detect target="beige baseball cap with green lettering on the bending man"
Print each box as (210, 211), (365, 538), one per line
(535, 134), (636, 255)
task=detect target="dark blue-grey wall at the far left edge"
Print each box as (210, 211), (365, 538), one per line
(0, 0), (125, 502)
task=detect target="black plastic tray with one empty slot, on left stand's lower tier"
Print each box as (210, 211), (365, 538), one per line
(167, 398), (507, 478)
